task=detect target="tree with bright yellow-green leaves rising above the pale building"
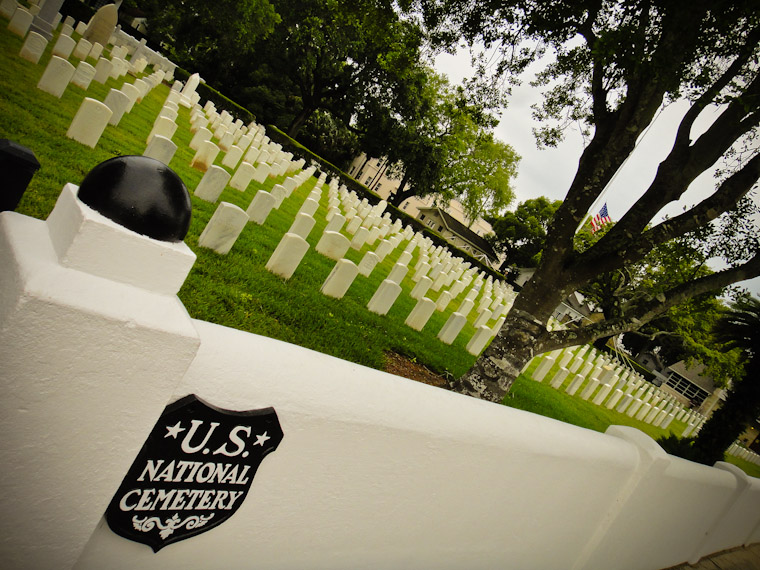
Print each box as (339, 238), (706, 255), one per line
(366, 65), (520, 215)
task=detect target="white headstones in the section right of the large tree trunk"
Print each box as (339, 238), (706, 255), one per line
(532, 345), (706, 437)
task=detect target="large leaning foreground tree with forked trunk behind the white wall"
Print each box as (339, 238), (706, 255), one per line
(422, 0), (760, 401)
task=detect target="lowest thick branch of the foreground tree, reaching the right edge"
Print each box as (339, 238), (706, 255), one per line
(541, 254), (760, 352)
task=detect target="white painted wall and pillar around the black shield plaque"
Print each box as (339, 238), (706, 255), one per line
(0, 187), (760, 570)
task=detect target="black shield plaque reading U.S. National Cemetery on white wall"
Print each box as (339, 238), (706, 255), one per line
(106, 394), (282, 552)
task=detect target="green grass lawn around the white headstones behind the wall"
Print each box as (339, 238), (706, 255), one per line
(0, 18), (760, 471)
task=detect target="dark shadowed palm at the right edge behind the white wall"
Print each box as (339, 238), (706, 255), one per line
(689, 297), (760, 465)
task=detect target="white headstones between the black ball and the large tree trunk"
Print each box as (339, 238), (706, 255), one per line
(145, 82), (514, 354)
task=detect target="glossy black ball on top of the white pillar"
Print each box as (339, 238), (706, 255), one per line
(78, 156), (192, 242)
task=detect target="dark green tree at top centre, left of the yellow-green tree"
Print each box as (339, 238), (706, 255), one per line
(251, 0), (422, 137)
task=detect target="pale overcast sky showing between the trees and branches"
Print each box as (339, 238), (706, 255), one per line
(435, 50), (760, 295)
